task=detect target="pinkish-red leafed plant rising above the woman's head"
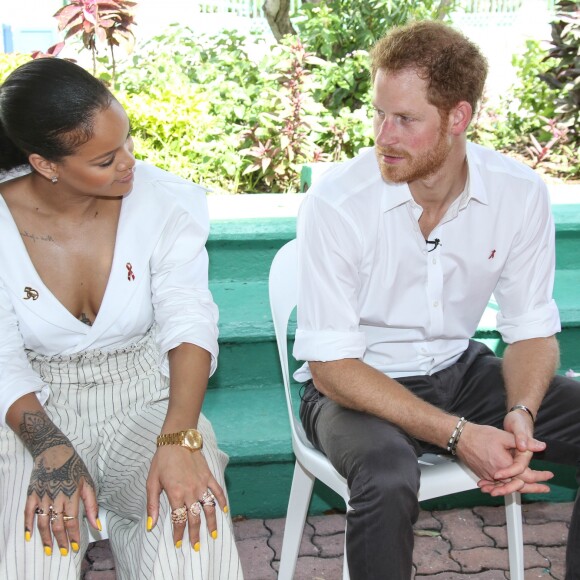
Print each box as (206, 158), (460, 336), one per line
(49, 0), (136, 79)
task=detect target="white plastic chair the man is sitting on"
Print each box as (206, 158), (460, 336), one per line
(269, 240), (524, 580)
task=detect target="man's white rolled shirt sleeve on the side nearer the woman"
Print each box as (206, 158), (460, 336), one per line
(293, 196), (366, 361)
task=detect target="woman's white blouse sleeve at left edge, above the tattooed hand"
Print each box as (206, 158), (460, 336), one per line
(0, 280), (48, 426)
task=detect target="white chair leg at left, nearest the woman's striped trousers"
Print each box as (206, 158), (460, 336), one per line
(278, 461), (315, 580)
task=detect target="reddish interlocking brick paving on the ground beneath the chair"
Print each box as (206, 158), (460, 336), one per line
(84, 503), (572, 580)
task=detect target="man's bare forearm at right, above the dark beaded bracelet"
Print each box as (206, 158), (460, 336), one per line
(503, 336), (560, 417)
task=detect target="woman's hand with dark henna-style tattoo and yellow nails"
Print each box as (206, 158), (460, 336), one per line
(19, 411), (101, 556)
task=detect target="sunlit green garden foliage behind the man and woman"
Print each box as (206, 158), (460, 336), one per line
(0, 0), (580, 193)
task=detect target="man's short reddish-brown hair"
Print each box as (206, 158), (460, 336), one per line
(371, 20), (487, 112)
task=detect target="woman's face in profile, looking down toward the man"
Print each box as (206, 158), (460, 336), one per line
(55, 100), (135, 197)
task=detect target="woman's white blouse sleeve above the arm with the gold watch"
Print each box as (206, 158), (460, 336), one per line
(151, 199), (218, 376)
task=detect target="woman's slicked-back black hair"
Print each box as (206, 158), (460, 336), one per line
(0, 58), (114, 171)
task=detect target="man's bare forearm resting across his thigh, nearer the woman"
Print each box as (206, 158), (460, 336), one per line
(309, 359), (457, 448)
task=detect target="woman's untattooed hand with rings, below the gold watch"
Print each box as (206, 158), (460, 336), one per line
(147, 445), (228, 552)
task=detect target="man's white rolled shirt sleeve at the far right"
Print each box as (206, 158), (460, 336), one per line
(494, 181), (561, 344)
